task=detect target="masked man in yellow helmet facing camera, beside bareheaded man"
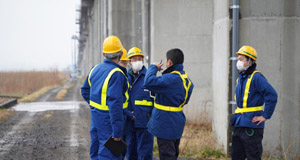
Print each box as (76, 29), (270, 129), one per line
(125, 47), (154, 160)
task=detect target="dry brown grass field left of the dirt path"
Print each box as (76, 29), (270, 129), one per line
(0, 71), (68, 121)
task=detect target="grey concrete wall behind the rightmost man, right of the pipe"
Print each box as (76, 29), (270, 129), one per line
(240, 0), (300, 159)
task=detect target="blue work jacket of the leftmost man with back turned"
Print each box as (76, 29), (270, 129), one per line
(81, 59), (128, 137)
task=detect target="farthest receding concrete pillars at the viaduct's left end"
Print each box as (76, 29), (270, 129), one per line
(79, 0), (104, 75)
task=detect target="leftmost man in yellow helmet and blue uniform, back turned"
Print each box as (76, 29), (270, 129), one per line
(81, 36), (129, 160)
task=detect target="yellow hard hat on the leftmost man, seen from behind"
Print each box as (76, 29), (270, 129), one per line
(103, 36), (123, 54)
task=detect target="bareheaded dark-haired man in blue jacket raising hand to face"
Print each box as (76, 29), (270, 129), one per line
(144, 48), (194, 160)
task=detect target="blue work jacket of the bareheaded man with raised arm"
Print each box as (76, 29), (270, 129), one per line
(144, 64), (194, 140)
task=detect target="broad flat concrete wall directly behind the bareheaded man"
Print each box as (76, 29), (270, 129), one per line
(150, 0), (213, 123)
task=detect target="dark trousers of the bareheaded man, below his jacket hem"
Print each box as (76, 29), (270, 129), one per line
(157, 137), (180, 160)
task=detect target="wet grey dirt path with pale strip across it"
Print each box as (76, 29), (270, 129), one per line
(0, 79), (90, 160)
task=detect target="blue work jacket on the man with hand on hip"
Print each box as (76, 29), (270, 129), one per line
(231, 64), (278, 128)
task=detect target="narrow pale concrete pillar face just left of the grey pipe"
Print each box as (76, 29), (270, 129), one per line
(212, 0), (231, 152)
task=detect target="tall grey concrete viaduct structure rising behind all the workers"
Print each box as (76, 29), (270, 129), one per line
(79, 0), (300, 159)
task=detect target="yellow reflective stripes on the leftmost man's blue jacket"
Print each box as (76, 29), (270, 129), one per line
(89, 67), (129, 111)
